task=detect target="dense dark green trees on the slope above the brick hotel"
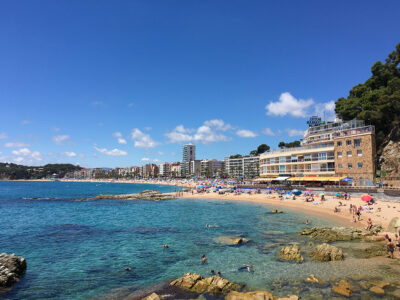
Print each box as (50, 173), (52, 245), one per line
(335, 44), (400, 145)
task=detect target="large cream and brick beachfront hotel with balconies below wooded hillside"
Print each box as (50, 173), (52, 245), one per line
(259, 117), (376, 186)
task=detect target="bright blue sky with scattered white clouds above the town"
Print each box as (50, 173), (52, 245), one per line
(0, 0), (400, 167)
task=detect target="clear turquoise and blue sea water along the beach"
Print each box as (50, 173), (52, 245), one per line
(0, 182), (338, 299)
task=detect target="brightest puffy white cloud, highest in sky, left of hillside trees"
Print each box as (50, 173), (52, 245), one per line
(265, 92), (314, 118)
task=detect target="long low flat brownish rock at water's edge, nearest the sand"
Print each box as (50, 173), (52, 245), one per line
(299, 227), (366, 242)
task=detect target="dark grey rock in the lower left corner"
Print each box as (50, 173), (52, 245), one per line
(0, 253), (26, 288)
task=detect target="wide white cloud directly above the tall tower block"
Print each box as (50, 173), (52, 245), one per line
(165, 120), (232, 144)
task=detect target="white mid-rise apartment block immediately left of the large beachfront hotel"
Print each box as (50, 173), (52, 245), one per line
(224, 156), (260, 178)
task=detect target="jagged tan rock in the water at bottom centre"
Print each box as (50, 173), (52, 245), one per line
(170, 273), (242, 295)
